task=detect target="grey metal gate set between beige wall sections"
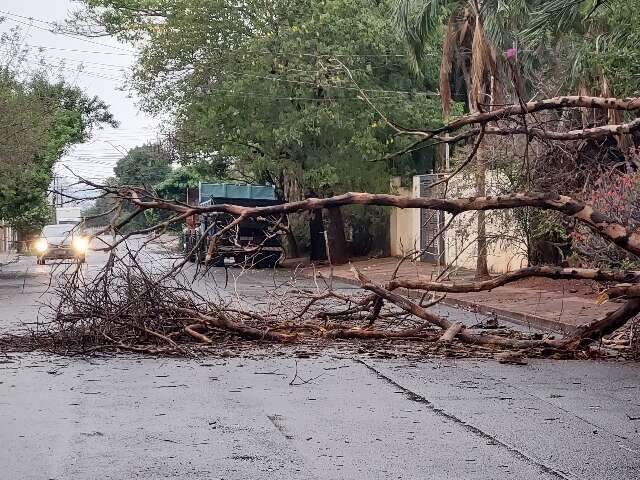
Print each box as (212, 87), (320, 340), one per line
(417, 173), (445, 265)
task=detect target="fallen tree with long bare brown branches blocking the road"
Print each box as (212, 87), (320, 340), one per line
(5, 93), (640, 355)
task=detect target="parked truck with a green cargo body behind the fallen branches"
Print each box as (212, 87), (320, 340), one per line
(183, 183), (284, 268)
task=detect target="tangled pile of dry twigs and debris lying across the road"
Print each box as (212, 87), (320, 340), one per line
(0, 252), (616, 358)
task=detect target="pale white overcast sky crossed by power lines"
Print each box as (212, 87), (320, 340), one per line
(0, 0), (159, 180)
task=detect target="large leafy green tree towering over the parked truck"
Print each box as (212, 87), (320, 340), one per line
(74, 0), (441, 255)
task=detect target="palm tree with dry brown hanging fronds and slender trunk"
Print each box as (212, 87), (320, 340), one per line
(395, 0), (532, 278)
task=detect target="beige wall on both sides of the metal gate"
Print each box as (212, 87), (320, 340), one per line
(390, 176), (527, 273)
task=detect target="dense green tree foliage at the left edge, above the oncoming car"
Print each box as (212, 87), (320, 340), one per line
(0, 67), (117, 232)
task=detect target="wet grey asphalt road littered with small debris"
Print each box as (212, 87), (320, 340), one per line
(0, 242), (640, 480)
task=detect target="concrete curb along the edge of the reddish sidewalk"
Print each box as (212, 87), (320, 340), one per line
(292, 269), (576, 335)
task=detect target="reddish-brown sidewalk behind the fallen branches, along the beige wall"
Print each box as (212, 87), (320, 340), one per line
(286, 257), (617, 333)
